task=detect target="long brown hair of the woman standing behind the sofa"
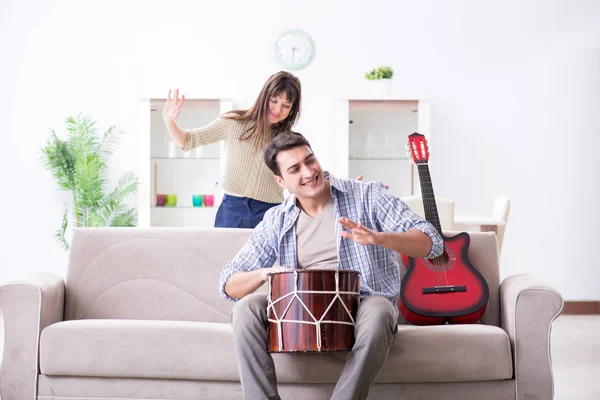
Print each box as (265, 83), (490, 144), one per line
(223, 71), (302, 143)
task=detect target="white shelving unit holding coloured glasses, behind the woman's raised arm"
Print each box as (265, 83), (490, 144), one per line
(138, 97), (232, 227)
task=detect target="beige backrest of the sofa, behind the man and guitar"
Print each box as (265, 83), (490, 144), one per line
(65, 228), (499, 325)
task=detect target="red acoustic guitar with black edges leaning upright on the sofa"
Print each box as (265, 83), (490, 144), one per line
(398, 133), (489, 325)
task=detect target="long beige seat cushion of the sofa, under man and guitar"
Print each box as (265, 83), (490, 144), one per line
(40, 320), (512, 383)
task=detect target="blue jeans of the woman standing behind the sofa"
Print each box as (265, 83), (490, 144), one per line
(215, 194), (279, 228)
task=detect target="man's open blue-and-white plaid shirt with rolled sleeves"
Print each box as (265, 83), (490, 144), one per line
(219, 172), (443, 306)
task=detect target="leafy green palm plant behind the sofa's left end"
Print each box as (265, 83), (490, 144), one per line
(41, 114), (138, 250)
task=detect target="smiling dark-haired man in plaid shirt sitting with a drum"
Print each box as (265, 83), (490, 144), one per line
(220, 132), (443, 400)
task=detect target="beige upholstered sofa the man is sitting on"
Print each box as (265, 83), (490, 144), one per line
(0, 228), (563, 400)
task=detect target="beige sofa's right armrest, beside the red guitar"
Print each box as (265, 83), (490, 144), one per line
(500, 274), (564, 399)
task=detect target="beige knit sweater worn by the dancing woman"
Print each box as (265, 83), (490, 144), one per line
(183, 117), (283, 203)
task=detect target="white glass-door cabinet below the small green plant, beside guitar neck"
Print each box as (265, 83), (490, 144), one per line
(334, 98), (431, 197)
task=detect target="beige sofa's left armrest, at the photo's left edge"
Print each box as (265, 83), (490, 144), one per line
(0, 274), (65, 400)
